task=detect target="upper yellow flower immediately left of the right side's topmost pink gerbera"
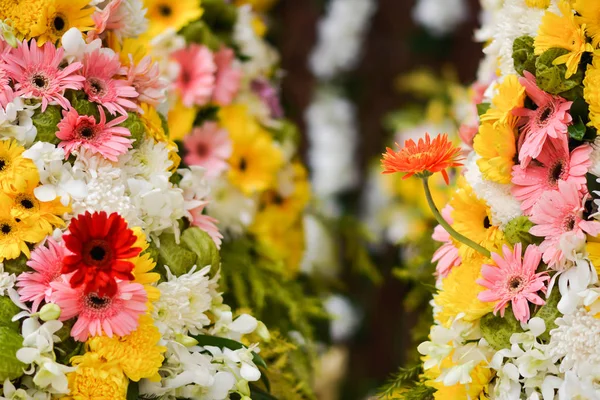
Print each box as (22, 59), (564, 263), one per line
(481, 75), (525, 125)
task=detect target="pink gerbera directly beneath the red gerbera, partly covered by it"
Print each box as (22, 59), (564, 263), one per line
(50, 279), (148, 342)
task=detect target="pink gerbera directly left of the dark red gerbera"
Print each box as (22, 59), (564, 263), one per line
(16, 238), (65, 312)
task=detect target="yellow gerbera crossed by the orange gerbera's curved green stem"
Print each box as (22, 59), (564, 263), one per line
(450, 179), (505, 261)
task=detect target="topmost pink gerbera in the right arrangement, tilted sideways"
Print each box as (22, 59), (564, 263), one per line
(513, 71), (573, 168)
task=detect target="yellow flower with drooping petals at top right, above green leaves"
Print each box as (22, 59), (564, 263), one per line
(533, 0), (594, 78)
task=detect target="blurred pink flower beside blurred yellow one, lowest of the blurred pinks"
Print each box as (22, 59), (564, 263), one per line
(183, 122), (232, 178)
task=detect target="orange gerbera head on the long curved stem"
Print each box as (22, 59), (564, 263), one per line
(381, 133), (462, 184)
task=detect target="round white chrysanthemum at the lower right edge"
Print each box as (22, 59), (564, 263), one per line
(548, 307), (600, 380)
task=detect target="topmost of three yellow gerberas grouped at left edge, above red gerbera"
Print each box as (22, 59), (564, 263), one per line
(0, 139), (40, 193)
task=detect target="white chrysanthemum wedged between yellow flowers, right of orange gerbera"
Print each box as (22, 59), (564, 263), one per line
(464, 152), (523, 228)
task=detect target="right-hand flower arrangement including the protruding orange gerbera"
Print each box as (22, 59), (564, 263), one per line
(382, 0), (600, 400)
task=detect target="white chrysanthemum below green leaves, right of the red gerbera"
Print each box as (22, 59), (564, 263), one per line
(152, 266), (214, 339)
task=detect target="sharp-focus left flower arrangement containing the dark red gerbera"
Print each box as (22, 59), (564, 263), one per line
(0, 0), (272, 400)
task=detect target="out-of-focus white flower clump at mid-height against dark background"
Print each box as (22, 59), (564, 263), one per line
(305, 91), (358, 197)
